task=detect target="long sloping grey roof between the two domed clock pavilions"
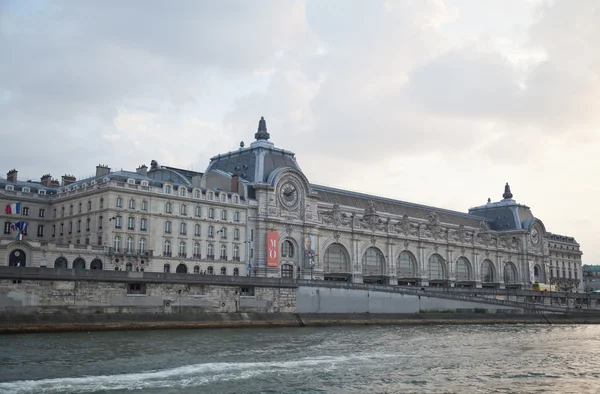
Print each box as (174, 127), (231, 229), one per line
(311, 184), (489, 227)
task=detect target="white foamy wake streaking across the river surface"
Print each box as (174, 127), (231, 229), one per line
(0, 354), (398, 394)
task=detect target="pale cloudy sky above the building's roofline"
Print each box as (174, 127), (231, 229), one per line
(0, 0), (600, 264)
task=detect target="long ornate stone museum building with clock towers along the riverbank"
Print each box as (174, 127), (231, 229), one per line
(0, 118), (583, 290)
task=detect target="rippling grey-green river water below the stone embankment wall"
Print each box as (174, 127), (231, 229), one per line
(0, 325), (600, 394)
